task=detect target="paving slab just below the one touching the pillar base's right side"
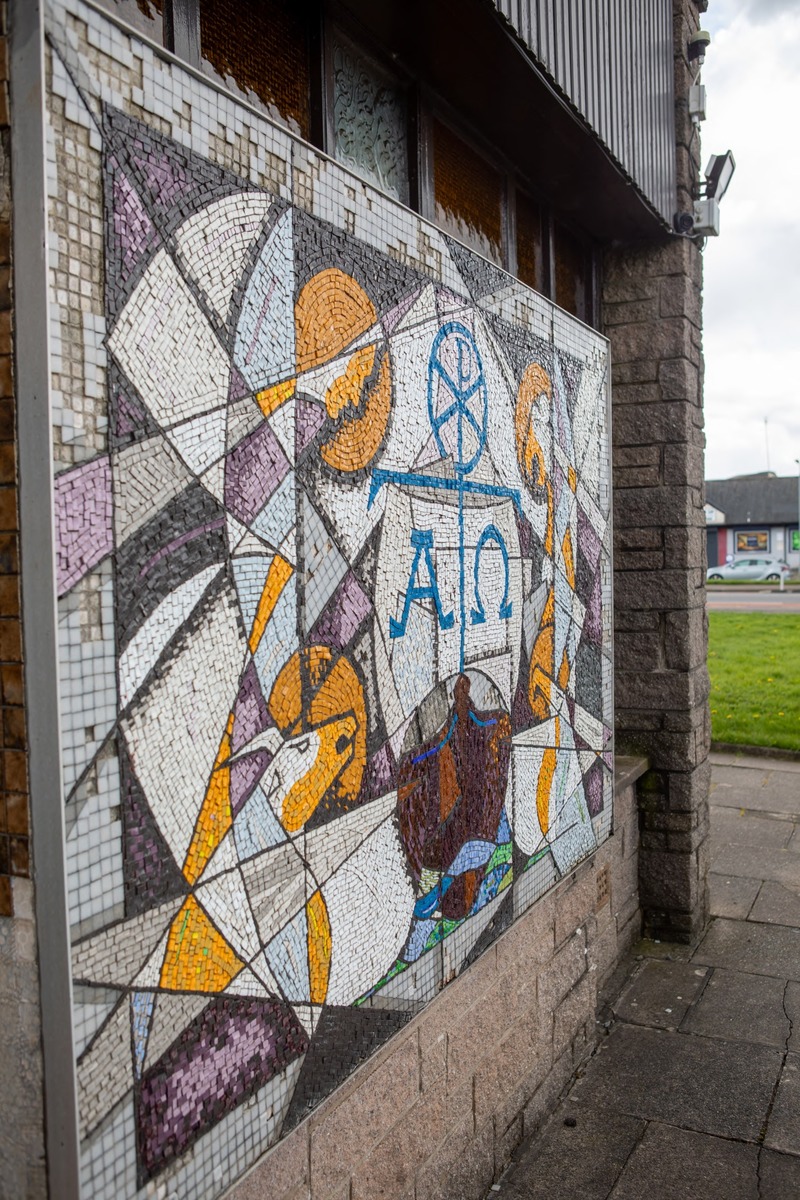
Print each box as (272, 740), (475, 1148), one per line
(680, 967), (790, 1049)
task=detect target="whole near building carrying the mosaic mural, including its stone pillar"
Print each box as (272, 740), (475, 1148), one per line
(0, 0), (709, 1200)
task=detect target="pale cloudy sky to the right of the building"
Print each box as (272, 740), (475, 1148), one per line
(702, 0), (800, 479)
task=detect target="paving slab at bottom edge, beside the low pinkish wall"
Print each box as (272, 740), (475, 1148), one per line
(492, 1105), (645, 1200)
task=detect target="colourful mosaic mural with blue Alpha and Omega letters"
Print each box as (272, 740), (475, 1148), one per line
(53, 4), (612, 1196)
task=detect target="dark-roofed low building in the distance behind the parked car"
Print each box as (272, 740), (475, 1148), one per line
(705, 472), (800, 566)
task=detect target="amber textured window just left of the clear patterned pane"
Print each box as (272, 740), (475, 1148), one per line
(200, 0), (311, 139)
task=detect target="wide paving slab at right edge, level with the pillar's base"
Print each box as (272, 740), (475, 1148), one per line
(692, 917), (800, 980)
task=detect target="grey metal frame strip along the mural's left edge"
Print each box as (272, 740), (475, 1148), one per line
(9, 0), (80, 1200)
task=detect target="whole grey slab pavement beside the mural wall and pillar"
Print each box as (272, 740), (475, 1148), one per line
(489, 755), (800, 1200)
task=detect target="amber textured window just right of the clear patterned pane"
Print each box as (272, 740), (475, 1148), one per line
(432, 118), (505, 266)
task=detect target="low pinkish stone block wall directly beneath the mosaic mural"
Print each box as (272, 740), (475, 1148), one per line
(229, 758), (645, 1200)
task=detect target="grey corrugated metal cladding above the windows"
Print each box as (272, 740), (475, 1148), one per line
(495, 0), (675, 221)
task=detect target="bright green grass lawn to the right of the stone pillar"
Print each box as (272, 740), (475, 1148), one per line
(709, 612), (800, 750)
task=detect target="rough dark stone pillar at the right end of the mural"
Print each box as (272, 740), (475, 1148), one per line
(602, 0), (710, 940)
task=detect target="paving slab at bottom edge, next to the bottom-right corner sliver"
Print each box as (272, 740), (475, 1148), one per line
(609, 1122), (762, 1200)
